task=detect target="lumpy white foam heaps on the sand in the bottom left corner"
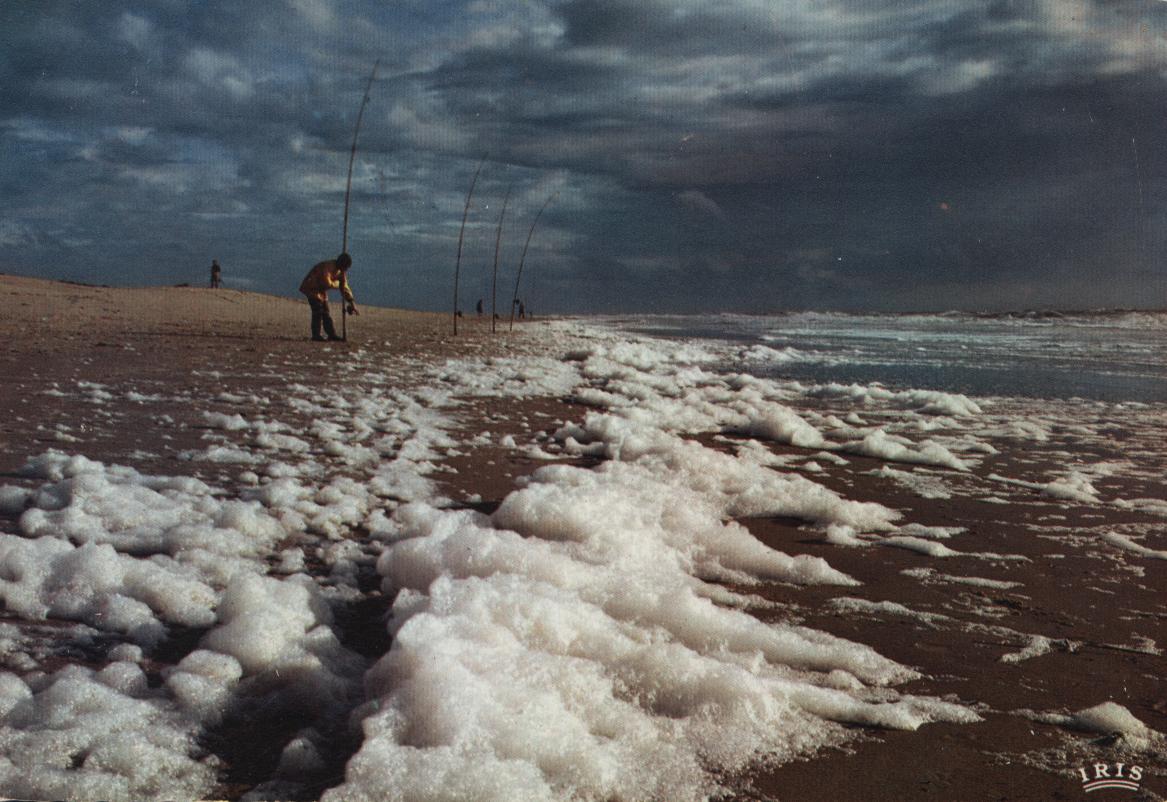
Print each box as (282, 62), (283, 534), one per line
(0, 452), (364, 800)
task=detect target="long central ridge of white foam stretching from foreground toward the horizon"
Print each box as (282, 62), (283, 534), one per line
(326, 329), (994, 802)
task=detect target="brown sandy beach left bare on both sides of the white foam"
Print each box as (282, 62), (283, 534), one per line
(0, 276), (1167, 802)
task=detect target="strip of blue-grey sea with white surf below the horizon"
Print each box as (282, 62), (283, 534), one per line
(605, 312), (1167, 403)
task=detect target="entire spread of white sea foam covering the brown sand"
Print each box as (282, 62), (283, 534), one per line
(0, 317), (1059, 801)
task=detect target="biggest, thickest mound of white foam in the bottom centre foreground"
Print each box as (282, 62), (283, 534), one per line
(326, 480), (976, 800)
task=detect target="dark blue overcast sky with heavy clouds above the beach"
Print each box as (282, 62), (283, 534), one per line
(0, 0), (1167, 312)
